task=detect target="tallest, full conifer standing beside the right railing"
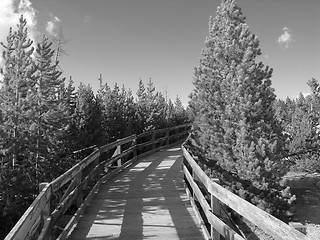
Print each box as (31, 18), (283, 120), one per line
(190, 0), (294, 216)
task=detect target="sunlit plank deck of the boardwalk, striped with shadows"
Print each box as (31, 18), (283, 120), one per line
(68, 146), (204, 240)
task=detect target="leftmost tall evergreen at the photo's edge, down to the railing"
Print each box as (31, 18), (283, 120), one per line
(0, 16), (37, 234)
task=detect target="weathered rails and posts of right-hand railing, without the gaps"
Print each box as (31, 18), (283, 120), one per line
(182, 142), (308, 240)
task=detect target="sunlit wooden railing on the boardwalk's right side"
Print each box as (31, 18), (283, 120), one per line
(182, 137), (309, 240)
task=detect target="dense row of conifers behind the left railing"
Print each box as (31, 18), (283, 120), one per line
(0, 17), (188, 236)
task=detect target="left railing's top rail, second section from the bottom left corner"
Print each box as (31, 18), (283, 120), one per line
(51, 149), (100, 192)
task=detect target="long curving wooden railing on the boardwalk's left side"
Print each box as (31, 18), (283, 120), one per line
(5, 124), (191, 240)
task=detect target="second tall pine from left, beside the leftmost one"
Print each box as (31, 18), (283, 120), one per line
(30, 36), (68, 181)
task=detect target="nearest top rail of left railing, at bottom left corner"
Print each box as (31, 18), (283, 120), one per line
(5, 184), (52, 240)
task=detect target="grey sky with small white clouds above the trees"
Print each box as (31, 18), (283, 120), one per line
(0, 0), (320, 106)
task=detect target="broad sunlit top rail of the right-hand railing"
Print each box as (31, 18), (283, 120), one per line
(182, 147), (309, 240)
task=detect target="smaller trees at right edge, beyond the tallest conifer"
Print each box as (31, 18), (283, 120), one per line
(275, 79), (320, 172)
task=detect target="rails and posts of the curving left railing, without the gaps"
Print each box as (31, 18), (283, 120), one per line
(5, 124), (191, 240)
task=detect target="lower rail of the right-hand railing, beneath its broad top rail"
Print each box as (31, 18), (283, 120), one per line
(183, 166), (245, 240)
